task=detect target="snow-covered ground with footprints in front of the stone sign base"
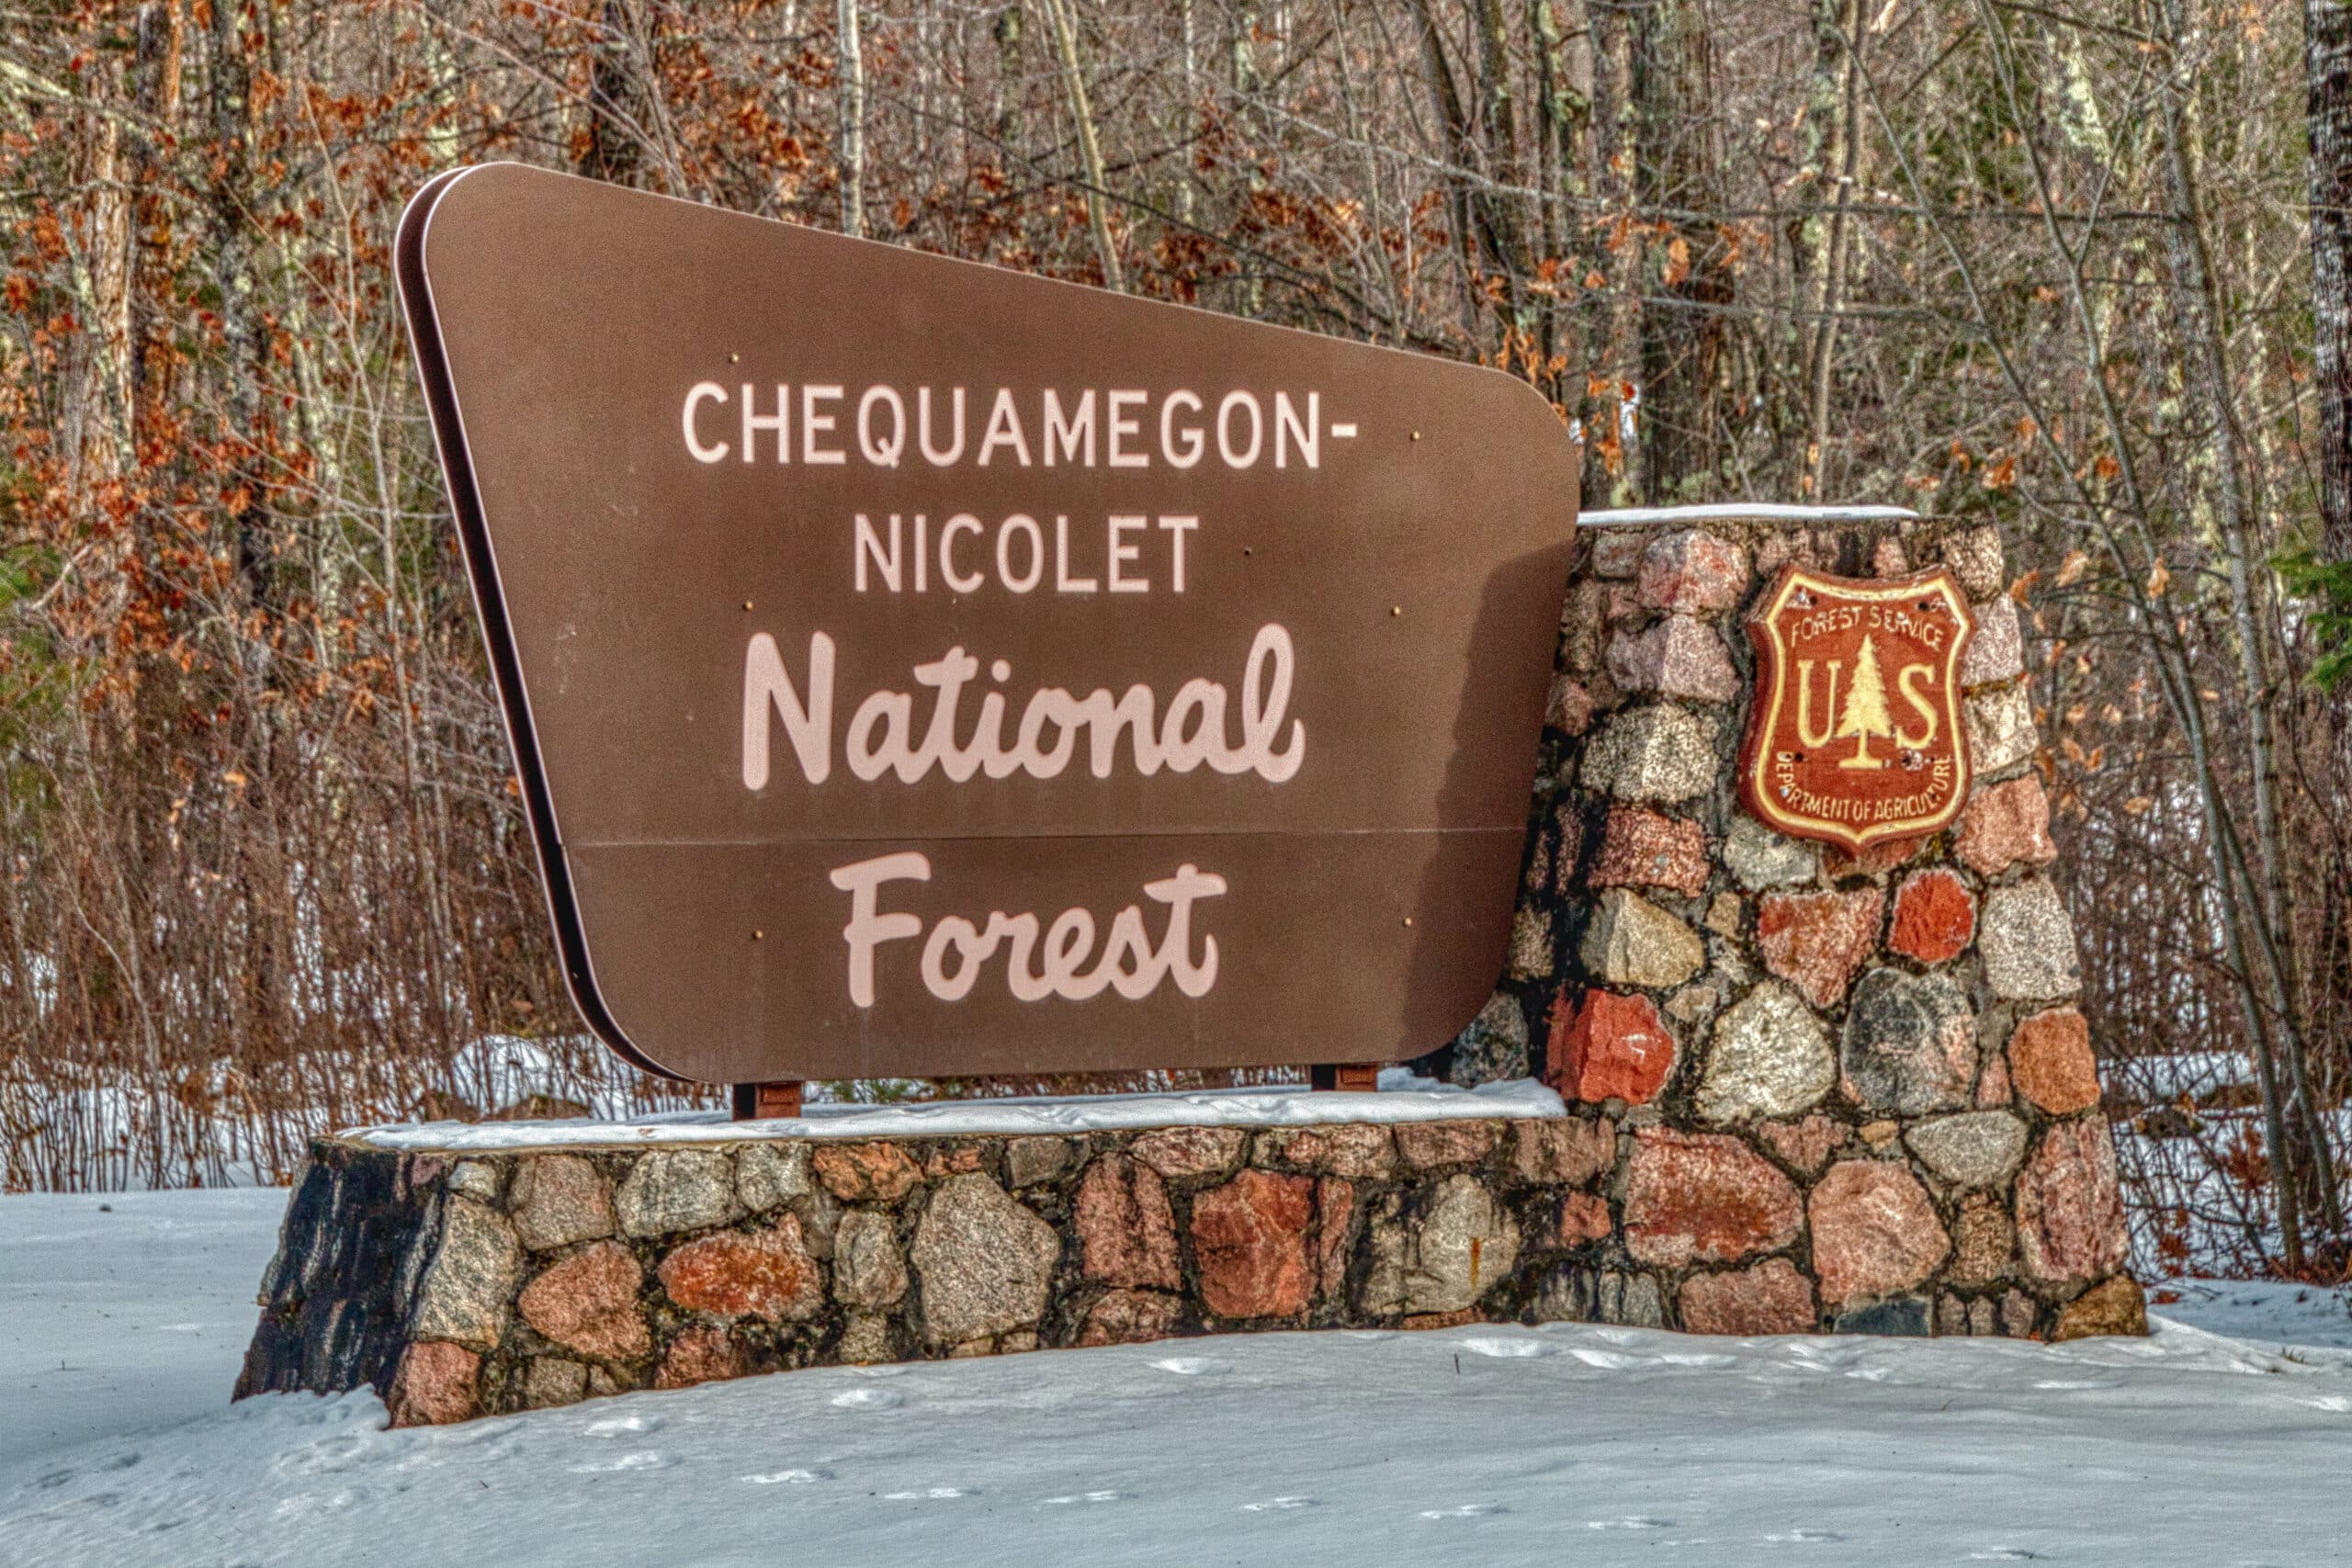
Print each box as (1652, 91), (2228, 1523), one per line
(0, 1192), (2352, 1568)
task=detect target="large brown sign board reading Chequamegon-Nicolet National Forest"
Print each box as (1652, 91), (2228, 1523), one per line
(398, 164), (1576, 1081)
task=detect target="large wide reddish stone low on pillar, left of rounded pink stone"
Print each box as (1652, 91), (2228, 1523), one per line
(1625, 1128), (1802, 1267)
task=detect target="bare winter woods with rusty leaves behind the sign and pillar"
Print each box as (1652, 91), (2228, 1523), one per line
(0, 0), (2352, 1279)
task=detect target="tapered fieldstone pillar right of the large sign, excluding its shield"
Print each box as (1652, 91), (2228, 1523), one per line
(1452, 512), (2143, 1336)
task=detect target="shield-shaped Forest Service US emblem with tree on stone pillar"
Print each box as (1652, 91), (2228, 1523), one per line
(1740, 567), (1975, 853)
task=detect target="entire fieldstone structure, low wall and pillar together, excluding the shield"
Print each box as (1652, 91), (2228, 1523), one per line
(238, 522), (2145, 1425)
